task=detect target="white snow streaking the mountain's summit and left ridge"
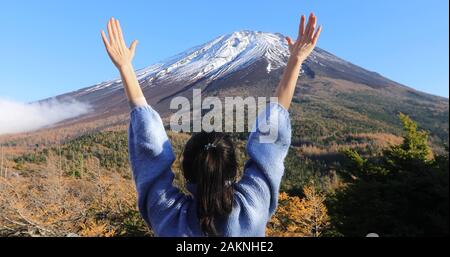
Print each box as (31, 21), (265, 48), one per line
(77, 31), (288, 95)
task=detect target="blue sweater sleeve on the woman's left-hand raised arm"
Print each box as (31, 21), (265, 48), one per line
(128, 105), (185, 235)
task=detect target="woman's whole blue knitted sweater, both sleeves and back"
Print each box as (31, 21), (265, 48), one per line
(129, 103), (291, 237)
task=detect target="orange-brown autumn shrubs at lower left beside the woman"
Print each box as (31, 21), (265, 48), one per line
(0, 152), (150, 237)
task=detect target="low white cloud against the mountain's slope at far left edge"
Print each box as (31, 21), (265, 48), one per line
(0, 99), (90, 135)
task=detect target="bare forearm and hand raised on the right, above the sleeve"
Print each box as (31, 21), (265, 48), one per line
(275, 13), (322, 109)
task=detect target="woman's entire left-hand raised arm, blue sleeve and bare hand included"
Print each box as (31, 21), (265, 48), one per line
(102, 18), (186, 236)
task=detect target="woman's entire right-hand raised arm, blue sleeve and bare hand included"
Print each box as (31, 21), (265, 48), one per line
(236, 14), (321, 225)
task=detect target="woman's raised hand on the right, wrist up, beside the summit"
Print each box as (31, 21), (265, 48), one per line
(286, 13), (322, 62)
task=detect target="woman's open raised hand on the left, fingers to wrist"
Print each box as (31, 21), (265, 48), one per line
(102, 18), (138, 69)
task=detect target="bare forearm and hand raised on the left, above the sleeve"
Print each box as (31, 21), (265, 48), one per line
(102, 18), (147, 106)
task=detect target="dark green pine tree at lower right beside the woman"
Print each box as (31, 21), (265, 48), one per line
(327, 114), (449, 236)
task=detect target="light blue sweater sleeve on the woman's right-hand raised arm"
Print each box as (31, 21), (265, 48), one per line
(237, 103), (291, 223)
